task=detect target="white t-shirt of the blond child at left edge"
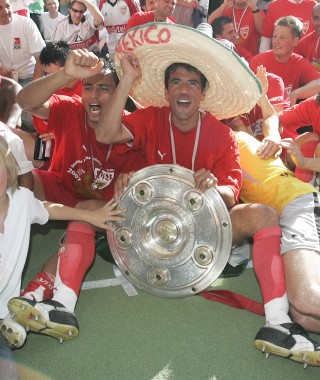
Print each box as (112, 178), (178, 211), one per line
(0, 187), (49, 319)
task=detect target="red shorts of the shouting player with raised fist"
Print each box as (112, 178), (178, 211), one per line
(33, 169), (85, 207)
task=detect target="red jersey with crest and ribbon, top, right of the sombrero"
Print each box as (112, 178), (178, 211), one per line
(223, 5), (264, 55)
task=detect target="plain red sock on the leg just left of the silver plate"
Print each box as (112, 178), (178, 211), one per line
(55, 222), (95, 295)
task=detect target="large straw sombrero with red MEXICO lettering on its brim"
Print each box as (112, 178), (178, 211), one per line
(115, 22), (261, 119)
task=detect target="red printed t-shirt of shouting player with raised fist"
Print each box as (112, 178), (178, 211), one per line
(41, 95), (145, 200)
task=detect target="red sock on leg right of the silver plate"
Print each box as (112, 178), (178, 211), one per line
(252, 226), (286, 304)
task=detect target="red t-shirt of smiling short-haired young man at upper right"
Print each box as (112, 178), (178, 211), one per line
(250, 50), (320, 94)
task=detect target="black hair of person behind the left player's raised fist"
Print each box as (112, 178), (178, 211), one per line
(39, 41), (71, 67)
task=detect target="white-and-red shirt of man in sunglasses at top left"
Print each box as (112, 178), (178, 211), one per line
(51, 13), (104, 51)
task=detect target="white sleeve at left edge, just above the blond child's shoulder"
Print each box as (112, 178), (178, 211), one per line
(0, 127), (33, 175)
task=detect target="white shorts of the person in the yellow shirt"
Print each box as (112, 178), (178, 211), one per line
(280, 192), (320, 255)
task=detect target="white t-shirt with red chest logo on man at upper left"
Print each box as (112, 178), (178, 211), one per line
(0, 14), (45, 79)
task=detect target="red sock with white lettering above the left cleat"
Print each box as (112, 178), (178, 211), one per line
(21, 272), (55, 302)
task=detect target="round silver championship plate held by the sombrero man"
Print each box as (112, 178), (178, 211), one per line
(107, 165), (232, 298)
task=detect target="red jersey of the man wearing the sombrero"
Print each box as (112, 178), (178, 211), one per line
(122, 107), (242, 200)
